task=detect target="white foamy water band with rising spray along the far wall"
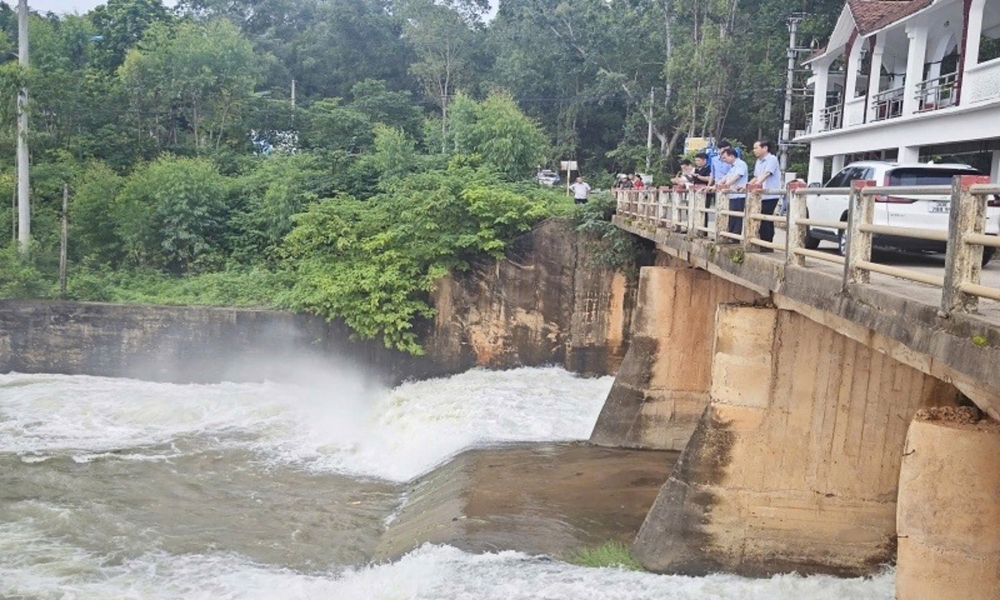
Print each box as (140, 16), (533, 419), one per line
(0, 368), (613, 481)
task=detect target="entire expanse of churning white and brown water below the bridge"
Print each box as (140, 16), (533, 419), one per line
(0, 368), (892, 600)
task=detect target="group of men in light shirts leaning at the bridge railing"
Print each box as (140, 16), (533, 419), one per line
(673, 140), (782, 252)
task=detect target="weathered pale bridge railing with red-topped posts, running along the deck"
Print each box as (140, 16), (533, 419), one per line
(618, 176), (1000, 316)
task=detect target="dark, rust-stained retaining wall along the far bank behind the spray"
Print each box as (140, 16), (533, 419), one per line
(0, 221), (636, 382)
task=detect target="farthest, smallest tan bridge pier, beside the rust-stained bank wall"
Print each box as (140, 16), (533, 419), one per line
(590, 266), (760, 450)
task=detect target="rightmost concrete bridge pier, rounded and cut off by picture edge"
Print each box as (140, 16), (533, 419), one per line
(896, 416), (1000, 600)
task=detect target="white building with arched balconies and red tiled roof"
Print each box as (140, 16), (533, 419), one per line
(796, 0), (1000, 182)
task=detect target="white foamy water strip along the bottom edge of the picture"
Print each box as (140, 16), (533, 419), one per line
(0, 525), (893, 600)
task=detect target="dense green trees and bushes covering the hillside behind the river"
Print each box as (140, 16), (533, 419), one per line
(0, 0), (842, 351)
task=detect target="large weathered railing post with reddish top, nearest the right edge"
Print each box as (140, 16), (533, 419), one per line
(941, 175), (990, 316)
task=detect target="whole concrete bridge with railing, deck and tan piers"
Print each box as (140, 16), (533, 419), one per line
(591, 182), (1000, 600)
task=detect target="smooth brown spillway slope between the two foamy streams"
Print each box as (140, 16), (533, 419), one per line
(375, 444), (678, 560)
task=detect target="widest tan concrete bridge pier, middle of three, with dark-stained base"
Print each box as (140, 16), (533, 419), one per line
(633, 305), (957, 576)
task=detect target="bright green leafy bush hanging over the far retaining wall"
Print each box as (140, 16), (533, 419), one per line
(285, 163), (566, 354)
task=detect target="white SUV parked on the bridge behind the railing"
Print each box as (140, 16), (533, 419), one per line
(805, 161), (1000, 265)
